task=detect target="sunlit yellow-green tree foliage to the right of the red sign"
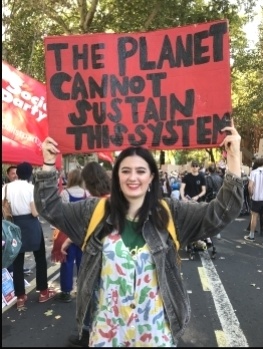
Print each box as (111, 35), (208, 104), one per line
(232, 7), (263, 161)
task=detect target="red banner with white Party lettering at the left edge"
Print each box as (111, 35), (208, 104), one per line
(2, 61), (113, 168)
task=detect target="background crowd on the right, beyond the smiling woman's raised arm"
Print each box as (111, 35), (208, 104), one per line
(160, 156), (263, 245)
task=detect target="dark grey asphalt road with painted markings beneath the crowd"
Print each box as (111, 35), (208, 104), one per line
(2, 213), (263, 347)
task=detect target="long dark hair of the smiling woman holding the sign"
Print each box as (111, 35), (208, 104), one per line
(110, 147), (168, 232)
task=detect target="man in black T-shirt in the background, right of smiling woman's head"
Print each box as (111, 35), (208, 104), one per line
(180, 160), (206, 202)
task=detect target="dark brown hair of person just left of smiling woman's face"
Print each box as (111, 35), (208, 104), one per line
(81, 161), (111, 197)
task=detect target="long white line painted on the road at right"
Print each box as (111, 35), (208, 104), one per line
(199, 251), (249, 348)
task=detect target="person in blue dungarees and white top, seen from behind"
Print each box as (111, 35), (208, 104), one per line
(52, 168), (90, 303)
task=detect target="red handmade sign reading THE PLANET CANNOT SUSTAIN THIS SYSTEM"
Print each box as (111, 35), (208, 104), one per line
(45, 21), (231, 154)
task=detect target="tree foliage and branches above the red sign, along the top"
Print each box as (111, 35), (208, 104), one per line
(2, 0), (254, 81)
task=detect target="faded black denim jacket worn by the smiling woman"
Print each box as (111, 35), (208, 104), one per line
(34, 171), (243, 343)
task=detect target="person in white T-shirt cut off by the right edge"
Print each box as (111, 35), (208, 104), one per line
(244, 157), (263, 241)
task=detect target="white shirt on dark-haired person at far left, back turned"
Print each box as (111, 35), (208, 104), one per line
(2, 179), (34, 216)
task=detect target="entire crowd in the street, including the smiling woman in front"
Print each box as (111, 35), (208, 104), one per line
(2, 125), (263, 347)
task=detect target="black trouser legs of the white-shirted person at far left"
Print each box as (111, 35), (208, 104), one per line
(13, 234), (48, 297)
